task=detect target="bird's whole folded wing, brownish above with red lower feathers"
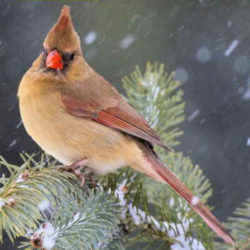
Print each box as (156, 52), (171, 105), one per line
(62, 76), (169, 150)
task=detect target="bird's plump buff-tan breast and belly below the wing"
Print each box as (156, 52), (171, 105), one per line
(19, 84), (137, 174)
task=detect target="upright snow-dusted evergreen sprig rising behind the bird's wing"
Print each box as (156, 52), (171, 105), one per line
(122, 62), (185, 147)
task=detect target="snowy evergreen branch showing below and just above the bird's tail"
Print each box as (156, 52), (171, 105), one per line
(100, 153), (213, 250)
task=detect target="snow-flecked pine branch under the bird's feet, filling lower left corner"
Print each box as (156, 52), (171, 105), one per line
(0, 154), (120, 250)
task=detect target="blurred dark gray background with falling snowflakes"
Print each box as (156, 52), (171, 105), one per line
(0, 0), (250, 249)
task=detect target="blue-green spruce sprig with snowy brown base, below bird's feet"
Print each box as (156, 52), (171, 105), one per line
(22, 187), (120, 250)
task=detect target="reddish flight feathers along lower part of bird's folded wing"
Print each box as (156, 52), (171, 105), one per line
(62, 91), (169, 150)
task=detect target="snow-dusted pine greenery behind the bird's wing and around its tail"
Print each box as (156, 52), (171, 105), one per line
(103, 63), (213, 249)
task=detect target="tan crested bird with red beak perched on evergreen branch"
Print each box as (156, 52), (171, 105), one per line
(17, 5), (235, 245)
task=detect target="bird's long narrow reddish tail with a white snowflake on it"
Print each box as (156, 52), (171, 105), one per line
(142, 153), (235, 245)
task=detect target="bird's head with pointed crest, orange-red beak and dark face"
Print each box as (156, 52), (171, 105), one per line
(34, 6), (89, 78)
